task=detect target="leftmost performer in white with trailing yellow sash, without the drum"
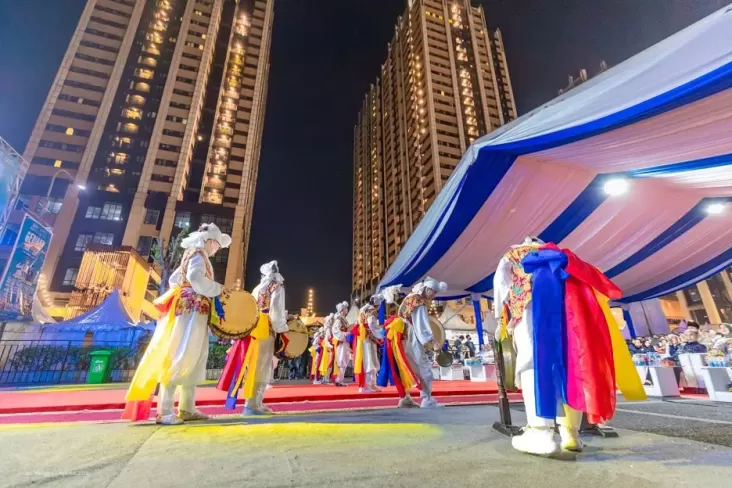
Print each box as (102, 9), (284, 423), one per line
(124, 224), (231, 425)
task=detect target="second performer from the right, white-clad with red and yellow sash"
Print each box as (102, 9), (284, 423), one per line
(386, 278), (447, 408)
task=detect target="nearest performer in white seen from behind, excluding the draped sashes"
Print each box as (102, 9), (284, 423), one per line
(493, 237), (583, 455)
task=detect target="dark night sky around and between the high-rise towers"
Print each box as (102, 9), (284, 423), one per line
(0, 0), (729, 313)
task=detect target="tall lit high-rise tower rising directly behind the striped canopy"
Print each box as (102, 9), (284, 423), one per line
(352, 0), (516, 297)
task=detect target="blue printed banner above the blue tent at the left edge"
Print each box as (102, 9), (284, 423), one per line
(0, 214), (51, 321)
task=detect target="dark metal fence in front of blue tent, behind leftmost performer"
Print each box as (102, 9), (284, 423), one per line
(0, 340), (234, 386)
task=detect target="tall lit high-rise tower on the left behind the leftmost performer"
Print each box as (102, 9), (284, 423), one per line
(10, 0), (274, 306)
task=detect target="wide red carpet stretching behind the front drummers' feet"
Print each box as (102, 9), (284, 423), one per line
(0, 381), (497, 414)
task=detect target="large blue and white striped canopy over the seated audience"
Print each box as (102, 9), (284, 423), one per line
(380, 6), (732, 302)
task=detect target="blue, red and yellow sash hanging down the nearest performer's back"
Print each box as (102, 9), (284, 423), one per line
(523, 244), (645, 424)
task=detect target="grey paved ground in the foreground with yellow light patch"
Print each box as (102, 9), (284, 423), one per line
(0, 405), (732, 488)
